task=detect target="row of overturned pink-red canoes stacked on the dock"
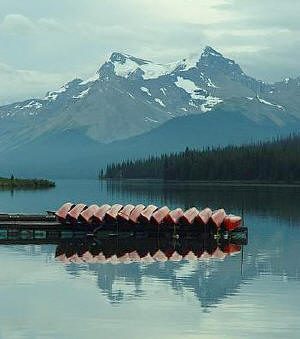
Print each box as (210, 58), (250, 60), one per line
(55, 202), (242, 231)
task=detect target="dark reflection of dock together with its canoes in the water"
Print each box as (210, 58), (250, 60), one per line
(0, 229), (247, 264)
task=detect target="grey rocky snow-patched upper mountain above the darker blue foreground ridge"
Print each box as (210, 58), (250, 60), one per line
(0, 47), (300, 151)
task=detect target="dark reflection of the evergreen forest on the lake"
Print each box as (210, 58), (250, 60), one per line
(105, 180), (300, 225)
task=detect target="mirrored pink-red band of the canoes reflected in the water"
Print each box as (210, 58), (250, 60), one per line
(56, 244), (241, 264)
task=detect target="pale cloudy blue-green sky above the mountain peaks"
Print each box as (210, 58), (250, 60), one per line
(0, 0), (300, 104)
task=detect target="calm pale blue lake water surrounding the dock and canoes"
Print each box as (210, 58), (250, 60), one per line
(0, 180), (300, 339)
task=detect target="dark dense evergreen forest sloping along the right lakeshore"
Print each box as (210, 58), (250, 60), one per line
(100, 135), (300, 182)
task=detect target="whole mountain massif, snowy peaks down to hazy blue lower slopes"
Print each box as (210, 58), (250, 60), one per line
(0, 47), (300, 176)
